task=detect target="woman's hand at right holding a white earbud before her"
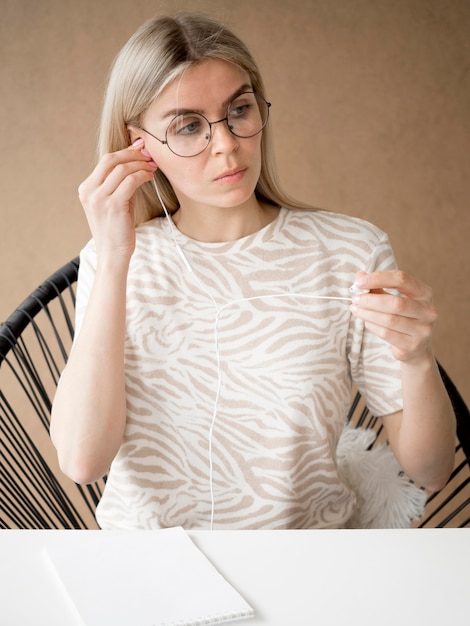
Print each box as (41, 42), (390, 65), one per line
(351, 270), (437, 362)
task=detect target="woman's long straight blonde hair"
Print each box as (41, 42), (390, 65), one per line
(99, 13), (306, 225)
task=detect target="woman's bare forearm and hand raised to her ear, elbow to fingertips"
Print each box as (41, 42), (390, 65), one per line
(50, 136), (156, 484)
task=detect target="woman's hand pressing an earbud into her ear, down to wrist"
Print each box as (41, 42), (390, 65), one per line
(78, 139), (157, 261)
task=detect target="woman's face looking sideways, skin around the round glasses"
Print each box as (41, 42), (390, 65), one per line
(137, 59), (261, 210)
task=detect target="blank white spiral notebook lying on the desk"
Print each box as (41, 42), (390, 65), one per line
(44, 527), (254, 626)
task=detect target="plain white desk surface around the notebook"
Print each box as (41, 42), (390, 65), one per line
(0, 529), (470, 626)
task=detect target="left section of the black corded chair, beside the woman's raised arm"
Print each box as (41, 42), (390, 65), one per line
(0, 258), (104, 528)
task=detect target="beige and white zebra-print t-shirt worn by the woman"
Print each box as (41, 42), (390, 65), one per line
(77, 209), (401, 529)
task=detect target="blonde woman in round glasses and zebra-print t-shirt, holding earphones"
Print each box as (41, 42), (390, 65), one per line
(51, 14), (455, 528)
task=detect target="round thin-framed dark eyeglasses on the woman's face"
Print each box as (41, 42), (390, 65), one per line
(141, 91), (271, 157)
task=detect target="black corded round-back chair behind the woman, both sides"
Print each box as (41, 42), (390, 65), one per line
(0, 258), (470, 528)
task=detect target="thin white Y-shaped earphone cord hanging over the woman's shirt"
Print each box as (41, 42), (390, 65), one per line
(153, 178), (369, 530)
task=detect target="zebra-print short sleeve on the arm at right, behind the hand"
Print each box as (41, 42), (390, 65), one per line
(348, 233), (403, 416)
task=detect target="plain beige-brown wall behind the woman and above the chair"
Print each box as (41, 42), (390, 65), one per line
(0, 0), (470, 401)
